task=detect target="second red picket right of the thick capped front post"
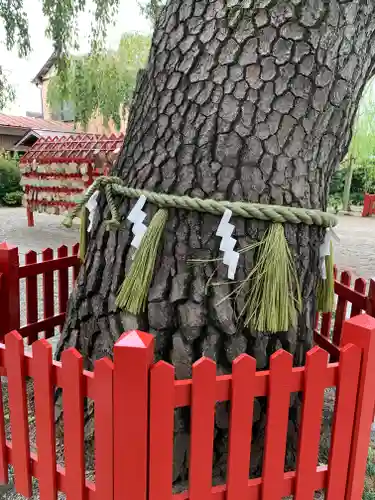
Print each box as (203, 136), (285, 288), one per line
(189, 358), (216, 500)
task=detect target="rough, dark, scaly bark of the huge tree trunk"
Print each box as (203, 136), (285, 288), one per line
(55, 0), (375, 480)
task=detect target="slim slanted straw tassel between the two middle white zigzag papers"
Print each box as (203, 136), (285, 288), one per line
(116, 209), (168, 315)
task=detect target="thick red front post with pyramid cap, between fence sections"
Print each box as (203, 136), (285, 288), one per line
(113, 331), (154, 500)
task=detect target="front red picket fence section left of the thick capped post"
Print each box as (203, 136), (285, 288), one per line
(0, 332), (114, 500)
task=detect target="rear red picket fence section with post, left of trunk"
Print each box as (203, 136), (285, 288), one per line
(0, 243), (80, 344)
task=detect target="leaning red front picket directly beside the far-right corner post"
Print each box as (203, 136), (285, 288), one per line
(325, 344), (361, 500)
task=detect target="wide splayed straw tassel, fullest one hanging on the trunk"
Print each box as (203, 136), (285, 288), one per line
(244, 223), (302, 333)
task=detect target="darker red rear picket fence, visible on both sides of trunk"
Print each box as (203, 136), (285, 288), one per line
(0, 238), (375, 352)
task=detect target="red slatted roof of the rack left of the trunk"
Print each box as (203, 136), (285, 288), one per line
(21, 134), (124, 164)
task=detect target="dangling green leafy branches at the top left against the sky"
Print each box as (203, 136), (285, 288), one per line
(0, 0), (120, 109)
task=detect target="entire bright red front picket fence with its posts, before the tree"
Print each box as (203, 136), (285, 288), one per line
(0, 315), (375, 500)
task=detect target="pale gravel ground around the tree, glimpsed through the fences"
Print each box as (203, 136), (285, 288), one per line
(0, 208), (375, 500)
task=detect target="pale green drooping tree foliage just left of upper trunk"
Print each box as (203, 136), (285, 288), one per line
(48, 33), (150, 128)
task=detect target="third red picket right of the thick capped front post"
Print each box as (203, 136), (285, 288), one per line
(227, 354), (256, 500)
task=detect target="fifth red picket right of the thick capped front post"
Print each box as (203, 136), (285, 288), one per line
(294, 347), (328, 500)
